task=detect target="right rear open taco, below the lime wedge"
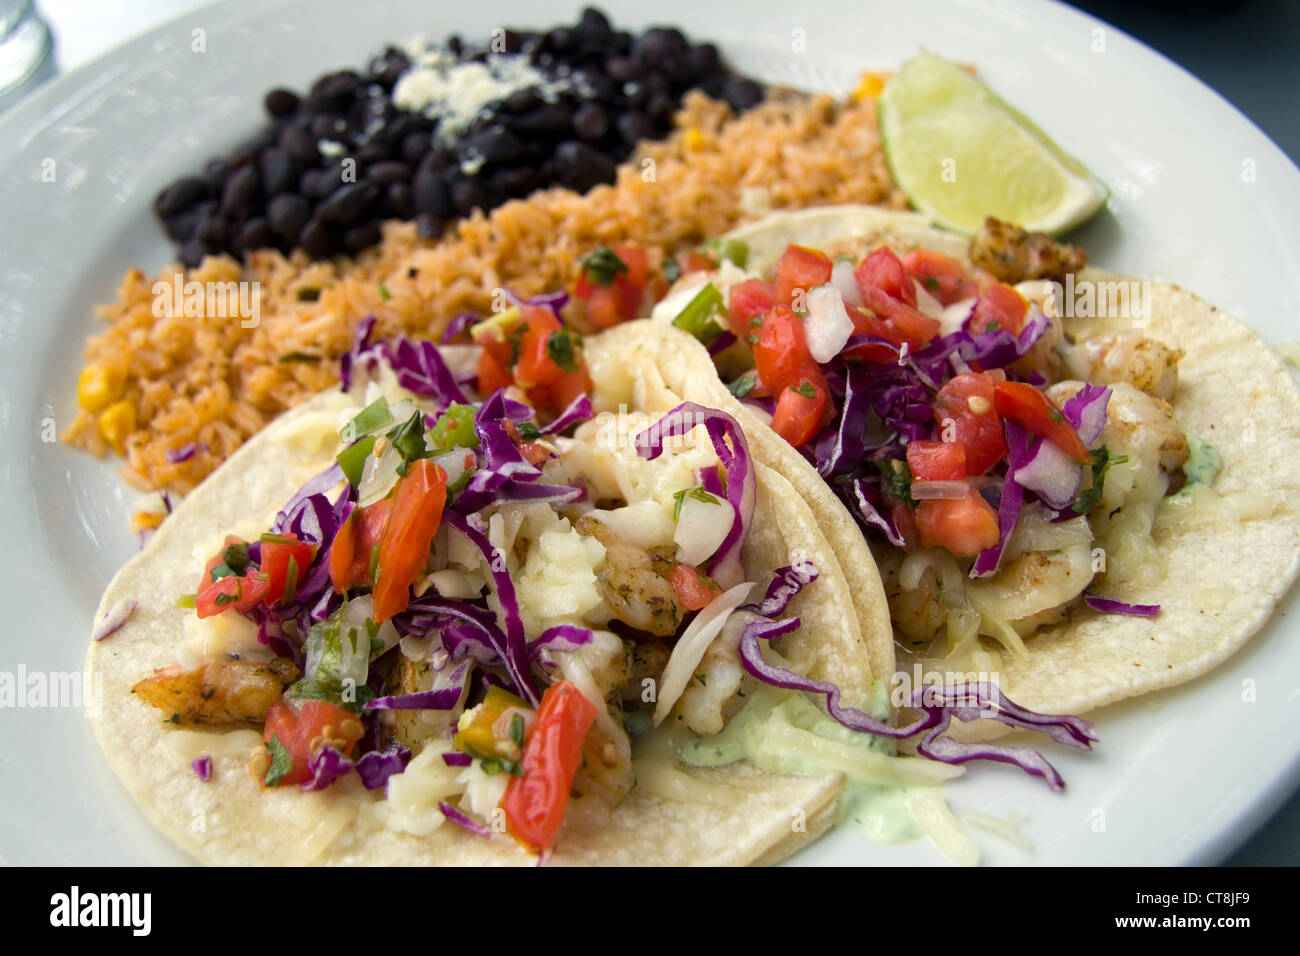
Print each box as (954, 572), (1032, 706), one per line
(634, 207), (1300, 714)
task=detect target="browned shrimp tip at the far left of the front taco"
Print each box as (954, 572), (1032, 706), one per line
(131, 654), (299, 727)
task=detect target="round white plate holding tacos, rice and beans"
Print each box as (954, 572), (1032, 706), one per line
(0, 0), (1300, 864)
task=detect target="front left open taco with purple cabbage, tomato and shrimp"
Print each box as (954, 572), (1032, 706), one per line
(88, 308), (1088, 864)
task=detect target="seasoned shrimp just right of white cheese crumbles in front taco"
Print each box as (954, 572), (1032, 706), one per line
(573, 516), (684, 637)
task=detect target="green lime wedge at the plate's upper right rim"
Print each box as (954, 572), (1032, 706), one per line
(879, 52), (1110, 234)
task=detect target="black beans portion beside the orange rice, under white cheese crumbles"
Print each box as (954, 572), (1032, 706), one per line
(155, 8), (766, 267)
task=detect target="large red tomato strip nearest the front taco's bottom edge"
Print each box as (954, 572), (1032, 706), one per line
(501, 680), (595, 852)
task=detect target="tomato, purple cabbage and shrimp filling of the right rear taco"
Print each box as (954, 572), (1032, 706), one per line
(653, 224), (1195, 656)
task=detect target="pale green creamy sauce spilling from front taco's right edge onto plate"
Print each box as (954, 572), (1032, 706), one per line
(676, 682), (922, 843)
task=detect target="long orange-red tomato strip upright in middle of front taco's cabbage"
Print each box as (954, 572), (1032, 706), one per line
(373, 458), (447, 623)
